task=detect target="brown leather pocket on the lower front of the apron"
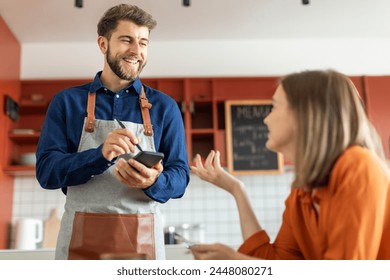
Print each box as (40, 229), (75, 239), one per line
(68, 212), (155, 260)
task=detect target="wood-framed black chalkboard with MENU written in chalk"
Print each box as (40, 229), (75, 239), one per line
(225, 100), (283, 174)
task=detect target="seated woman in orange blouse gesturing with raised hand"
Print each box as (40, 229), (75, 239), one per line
(191, 70), (390, 259)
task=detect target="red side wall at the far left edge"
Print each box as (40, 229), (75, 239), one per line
(0, 16), (21, 249)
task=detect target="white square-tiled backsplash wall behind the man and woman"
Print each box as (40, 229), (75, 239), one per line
(13, 170), (293, 247)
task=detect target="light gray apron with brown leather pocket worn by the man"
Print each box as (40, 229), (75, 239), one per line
(55, 93), (165, 259)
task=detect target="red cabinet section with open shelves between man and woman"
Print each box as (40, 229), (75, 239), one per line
(143, 77), (277, 165)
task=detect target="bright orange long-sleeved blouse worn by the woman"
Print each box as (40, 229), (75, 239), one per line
(238, 146), (390, 260)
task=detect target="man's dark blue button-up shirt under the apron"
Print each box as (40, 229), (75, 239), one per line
(36, 72), (190, 202)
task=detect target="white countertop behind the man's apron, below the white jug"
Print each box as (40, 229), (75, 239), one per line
(0, 244), (193, 260)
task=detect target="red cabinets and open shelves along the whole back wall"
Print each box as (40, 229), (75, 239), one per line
(5, 76), (384, 172)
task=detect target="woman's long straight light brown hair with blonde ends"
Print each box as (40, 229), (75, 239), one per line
(280, 70), (385, 188)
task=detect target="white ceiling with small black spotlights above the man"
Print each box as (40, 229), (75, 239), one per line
(0, 0), (390, 44)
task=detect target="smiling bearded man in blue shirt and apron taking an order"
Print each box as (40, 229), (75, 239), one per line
(36, 4), (189, 259)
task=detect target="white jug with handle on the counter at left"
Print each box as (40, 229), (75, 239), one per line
(15, 218), (43, 250)
